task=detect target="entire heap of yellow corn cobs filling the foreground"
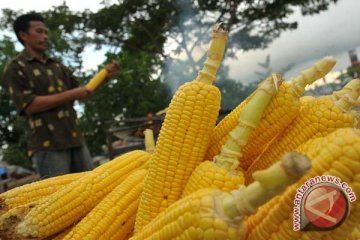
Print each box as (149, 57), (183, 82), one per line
(0, 24), (360, 240)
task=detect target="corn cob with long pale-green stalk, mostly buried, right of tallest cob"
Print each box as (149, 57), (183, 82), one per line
(183, 74), (283, 197)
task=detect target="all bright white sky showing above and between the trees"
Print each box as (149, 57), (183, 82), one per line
(0, 0), (360, 86)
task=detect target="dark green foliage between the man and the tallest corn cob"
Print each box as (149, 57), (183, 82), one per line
(81, 51), (170, 154)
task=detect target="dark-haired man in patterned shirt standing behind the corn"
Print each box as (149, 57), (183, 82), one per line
(4, 13), (119, 178)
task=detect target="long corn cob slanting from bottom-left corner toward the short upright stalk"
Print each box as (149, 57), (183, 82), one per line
(11, 150), (150, 238)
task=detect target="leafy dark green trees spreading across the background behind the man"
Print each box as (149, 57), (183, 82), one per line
(0, 0), (337, 161)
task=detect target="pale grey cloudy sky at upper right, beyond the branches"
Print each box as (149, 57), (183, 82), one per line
(227, 0), (360, 82)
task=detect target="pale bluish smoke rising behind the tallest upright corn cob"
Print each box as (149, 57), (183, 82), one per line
(163, 0), (217, 93)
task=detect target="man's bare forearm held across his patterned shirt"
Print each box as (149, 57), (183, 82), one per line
(24, 87), (91, 115)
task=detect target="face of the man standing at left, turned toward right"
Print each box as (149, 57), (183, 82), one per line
(20, 21), (48, 52)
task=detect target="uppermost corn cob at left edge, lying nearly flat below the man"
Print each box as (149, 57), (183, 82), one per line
(0, 172), (86, 215)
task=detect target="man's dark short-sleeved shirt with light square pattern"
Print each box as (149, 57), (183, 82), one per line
(4, 51), (84, 152)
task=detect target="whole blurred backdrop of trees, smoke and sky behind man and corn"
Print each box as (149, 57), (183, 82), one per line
(0, 0), (360, 175)
